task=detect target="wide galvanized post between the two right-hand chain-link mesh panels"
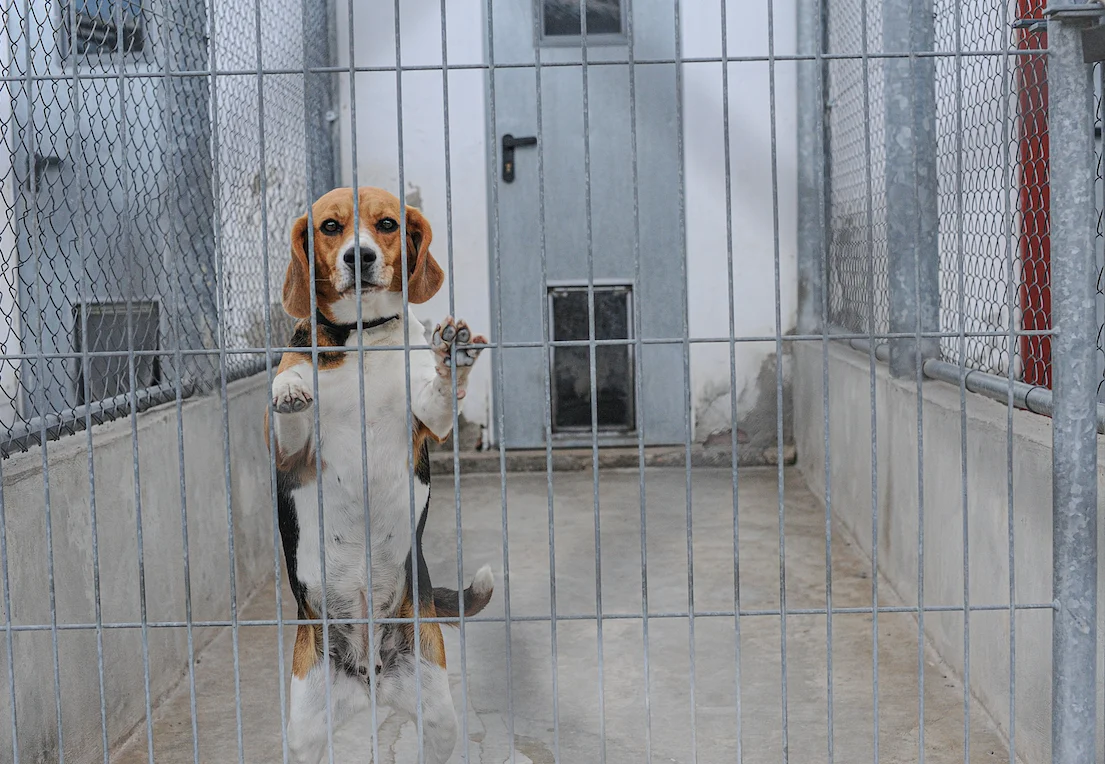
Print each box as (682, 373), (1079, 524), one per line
(883, 0), (940, 377)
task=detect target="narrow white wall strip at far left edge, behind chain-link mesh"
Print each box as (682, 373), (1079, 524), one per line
(0, 13), (20, 429)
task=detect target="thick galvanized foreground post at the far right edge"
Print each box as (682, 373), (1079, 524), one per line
(1048, 3), (1102, 764)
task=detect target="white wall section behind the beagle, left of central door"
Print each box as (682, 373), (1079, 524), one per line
(336, 0), (491, 422)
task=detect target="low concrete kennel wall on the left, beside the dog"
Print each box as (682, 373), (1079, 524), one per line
(0, 375), (277, 764)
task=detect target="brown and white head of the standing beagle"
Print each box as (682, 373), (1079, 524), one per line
(284, 188), (445, 323)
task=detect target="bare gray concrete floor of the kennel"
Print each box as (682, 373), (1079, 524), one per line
(113, 469), (1008, 764)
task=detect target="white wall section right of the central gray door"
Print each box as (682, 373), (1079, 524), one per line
(682, 0), (797, 439)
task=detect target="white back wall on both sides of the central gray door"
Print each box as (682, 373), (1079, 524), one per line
(337, 0), (796, 437)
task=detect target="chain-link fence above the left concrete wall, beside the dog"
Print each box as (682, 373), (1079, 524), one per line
(0, 0), (334, 454)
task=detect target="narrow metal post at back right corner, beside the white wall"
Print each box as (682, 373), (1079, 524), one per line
(797, 0), (828, 334)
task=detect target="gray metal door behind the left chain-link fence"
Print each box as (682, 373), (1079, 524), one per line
(6, 0), (168, 418)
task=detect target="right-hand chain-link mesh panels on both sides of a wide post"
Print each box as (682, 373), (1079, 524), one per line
(827, 0), (1051, 386)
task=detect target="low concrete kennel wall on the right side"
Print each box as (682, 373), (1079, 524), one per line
(793, 343), (1105, 762)
